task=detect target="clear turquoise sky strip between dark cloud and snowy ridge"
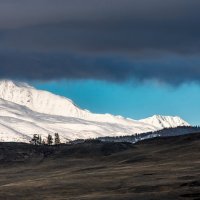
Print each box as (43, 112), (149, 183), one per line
(32, 80), (200, 125)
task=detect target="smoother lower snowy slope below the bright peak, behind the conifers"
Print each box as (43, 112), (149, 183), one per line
(0, 99), (156, 142)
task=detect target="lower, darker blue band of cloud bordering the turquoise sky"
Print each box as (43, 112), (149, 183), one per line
(0, 52), (200, 85)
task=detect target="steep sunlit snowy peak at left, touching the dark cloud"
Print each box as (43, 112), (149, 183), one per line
(0, 80), (87, 117)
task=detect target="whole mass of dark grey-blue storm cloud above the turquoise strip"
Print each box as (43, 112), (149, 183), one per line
(0, 0), (200, 84)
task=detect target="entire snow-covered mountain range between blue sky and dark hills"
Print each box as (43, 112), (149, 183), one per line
(0, 80), (189, 142)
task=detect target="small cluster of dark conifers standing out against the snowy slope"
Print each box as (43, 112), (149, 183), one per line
(30, 133), (61, 145)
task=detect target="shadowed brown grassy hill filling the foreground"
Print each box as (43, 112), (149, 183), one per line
(0, 134), (200, 200)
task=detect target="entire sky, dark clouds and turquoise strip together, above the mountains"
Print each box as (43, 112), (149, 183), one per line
(0, 0), (200, 124)
